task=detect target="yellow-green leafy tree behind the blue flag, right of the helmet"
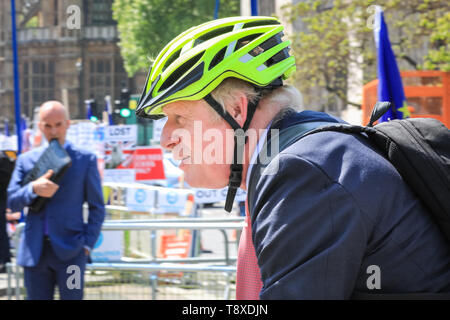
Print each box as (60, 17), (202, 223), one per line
(284, 0), (450, 106)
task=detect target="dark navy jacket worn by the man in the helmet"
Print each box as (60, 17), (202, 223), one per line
(250, 111), (450, 299)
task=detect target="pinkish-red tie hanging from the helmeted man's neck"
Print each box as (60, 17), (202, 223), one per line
(236, 200), (262, 300)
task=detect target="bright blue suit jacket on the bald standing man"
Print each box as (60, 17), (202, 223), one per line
(8, 142), (105, 267)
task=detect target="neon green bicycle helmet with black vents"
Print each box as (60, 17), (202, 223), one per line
(136, 16), (295, 119)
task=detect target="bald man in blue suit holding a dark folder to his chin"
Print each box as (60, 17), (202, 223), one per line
(8, 101), (105, 300)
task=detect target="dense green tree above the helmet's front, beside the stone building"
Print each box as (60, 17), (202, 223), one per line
(113, 0), (240, 77)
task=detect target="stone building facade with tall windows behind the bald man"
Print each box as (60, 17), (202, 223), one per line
(0, 0), (145, 128)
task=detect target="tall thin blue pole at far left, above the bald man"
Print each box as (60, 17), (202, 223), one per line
(11, 0), (22, 154)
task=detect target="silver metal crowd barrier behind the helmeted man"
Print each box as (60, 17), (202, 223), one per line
(7, 217), (244, 300)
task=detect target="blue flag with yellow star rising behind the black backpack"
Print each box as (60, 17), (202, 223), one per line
(374, 9), (410, 122)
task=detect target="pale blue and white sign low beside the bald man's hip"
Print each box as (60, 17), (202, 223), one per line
(91, 231), (123, 262)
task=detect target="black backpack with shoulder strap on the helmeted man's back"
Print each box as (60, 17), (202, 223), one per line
(248, 102), (450, 242)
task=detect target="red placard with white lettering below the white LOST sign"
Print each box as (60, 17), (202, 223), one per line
(130, 147), (166, 181)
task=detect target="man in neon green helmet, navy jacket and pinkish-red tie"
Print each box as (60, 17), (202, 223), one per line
(136, 17), (450, 299)
